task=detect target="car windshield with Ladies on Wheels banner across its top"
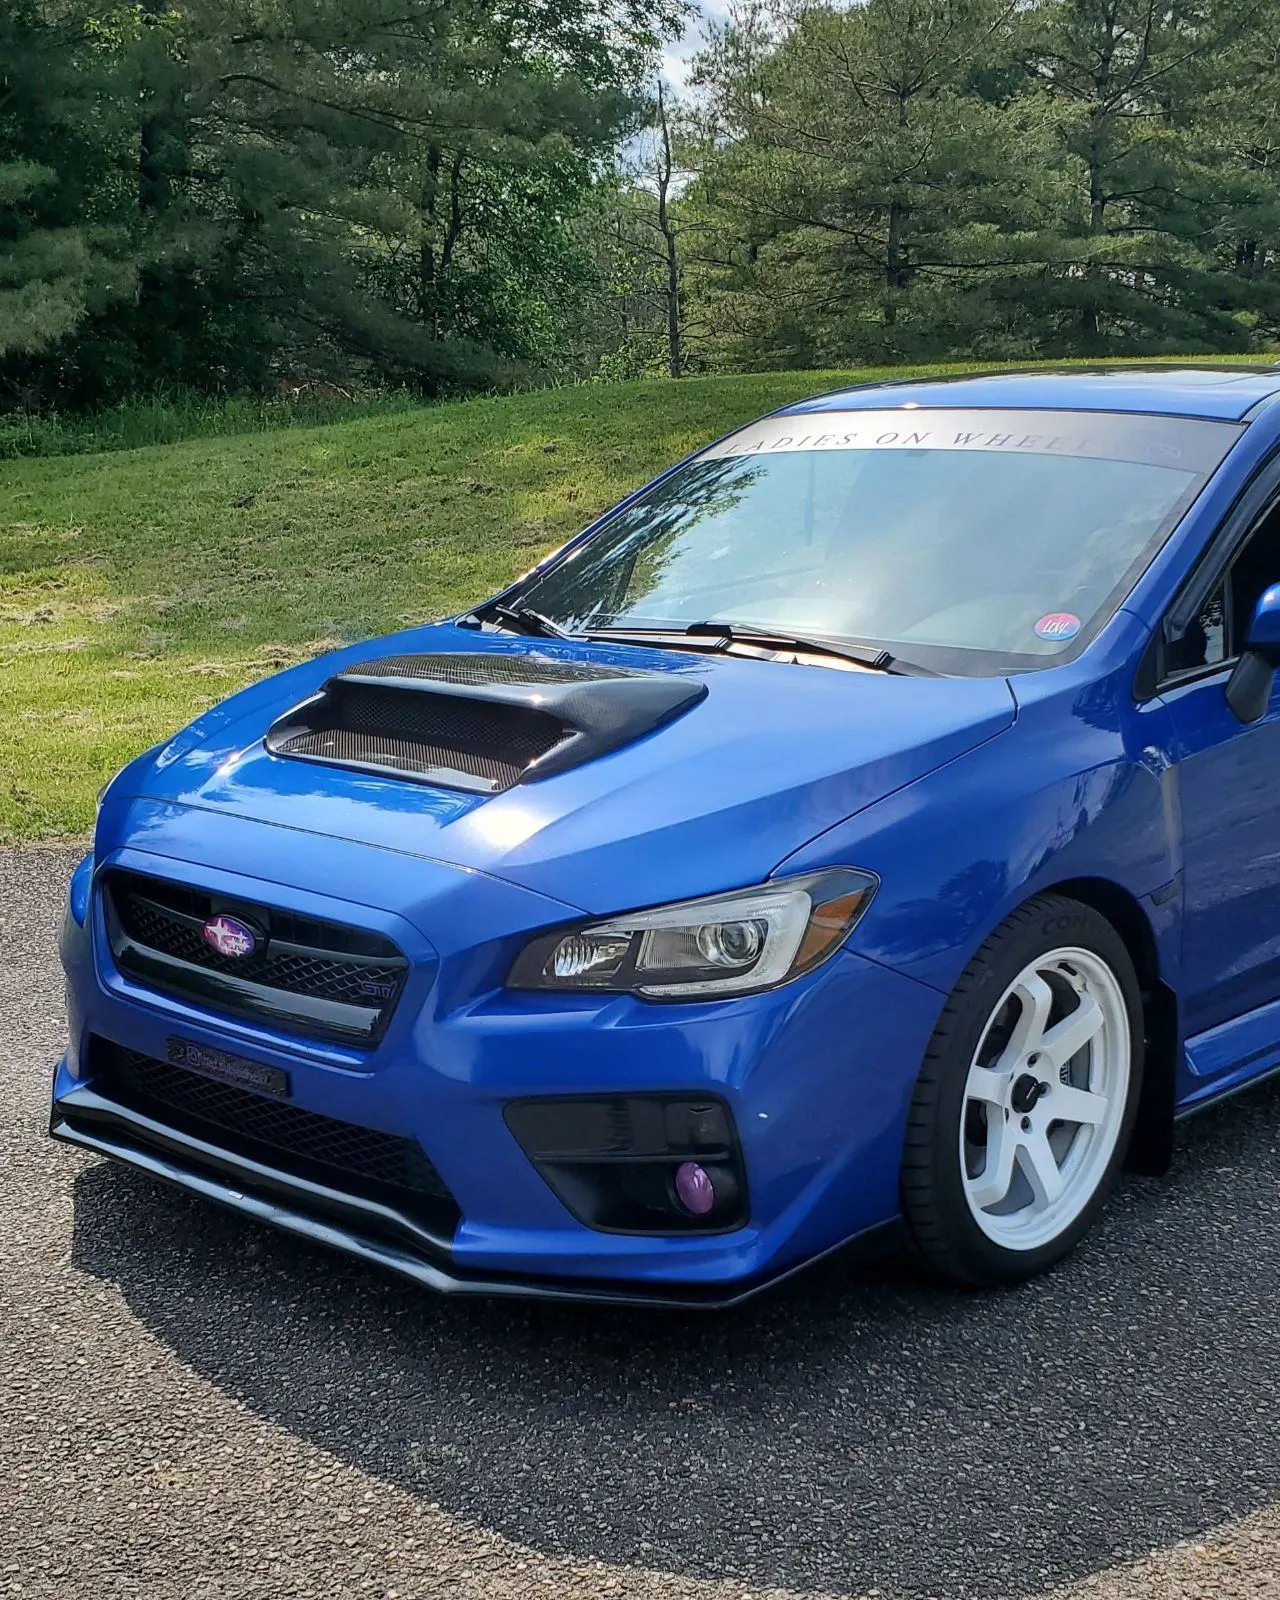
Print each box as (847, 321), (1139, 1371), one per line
(509, 408), (1242, 674)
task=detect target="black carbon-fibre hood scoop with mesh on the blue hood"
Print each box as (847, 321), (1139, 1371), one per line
(267, 653), (707, 794)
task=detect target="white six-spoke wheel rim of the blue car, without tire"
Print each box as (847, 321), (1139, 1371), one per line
(958, 946), (1131, 1251)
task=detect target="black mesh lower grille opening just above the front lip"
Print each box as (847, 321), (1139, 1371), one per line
(90, 1038), (459, 1232)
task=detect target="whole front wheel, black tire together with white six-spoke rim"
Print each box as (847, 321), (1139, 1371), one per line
(901, 894), (1142, 1288)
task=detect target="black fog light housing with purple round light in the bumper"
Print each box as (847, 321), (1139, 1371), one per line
(506, 1094), (747, 1235)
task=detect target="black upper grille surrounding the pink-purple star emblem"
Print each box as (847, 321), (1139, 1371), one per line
(106, 870), (408, 1030)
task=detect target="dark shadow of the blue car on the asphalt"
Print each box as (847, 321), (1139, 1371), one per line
(74, 1086), (1280, 1597)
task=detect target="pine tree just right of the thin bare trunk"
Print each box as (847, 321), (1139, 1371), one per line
(696, 0), (1051, 363)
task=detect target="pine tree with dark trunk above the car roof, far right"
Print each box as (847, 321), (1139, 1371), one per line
(1024, 0), (1269, 352)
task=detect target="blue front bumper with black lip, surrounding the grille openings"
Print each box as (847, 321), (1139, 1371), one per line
(51, 824), (941, 1306)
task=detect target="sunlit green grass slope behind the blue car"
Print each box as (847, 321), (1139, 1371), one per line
(0, 356), (1267, 842)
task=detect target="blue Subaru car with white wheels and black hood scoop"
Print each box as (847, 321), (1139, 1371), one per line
(51, 366), (1280, 1306)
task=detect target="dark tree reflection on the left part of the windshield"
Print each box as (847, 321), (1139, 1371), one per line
(522, 456), (765, 627)
